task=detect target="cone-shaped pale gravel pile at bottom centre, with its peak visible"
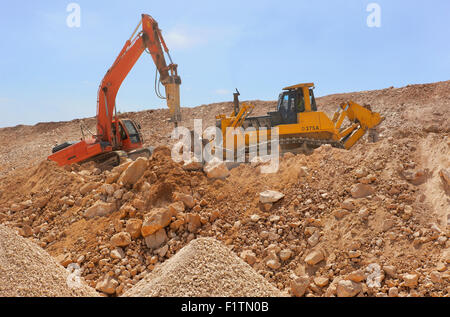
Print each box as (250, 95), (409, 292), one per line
(124, 238), (282, 297)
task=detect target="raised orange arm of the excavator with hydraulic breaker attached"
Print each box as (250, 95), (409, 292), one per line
(97, 14), (181, 146)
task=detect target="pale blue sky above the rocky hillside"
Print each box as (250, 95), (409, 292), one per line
(0, 0), (450, 127)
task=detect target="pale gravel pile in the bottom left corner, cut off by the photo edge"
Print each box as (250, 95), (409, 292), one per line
(0, 225), (98, 297)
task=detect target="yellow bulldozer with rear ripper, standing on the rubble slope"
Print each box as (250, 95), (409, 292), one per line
(216, 83), (383, 152)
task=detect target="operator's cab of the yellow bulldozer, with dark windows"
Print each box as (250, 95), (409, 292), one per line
(277, 84), (317, 124)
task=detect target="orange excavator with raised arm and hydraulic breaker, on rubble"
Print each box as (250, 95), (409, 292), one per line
(48, 14), (181, 167)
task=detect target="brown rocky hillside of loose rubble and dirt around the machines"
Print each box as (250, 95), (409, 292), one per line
(0, 82), (450, 297)
